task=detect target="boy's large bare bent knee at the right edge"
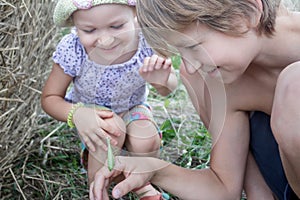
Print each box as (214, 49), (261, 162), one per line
(272, 61), (300, 198)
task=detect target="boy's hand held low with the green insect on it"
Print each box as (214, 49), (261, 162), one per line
(90, 156), (157, 200)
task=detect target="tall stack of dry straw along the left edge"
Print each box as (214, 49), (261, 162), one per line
(0, 0), (75, 199)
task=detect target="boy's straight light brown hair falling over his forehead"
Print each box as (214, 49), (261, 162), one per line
(136, 0), (280, 55)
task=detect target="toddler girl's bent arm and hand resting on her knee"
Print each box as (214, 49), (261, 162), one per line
(41, 63), (116, 151)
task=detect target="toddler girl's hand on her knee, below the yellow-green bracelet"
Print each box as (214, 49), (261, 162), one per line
(73, 107), (125, 152)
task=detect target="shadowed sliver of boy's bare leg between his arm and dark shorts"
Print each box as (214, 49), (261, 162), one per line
(244, 152), (275, 200)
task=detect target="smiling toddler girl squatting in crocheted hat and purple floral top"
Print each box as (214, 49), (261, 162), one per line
(42, 0), (178, 199)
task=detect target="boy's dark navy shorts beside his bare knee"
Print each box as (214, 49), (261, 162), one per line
(250, 112), (298, 200)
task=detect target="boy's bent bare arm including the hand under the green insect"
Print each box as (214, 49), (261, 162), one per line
(90, 111), (249, 200)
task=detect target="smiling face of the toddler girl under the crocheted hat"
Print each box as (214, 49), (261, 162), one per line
(72, 4), (139, 65)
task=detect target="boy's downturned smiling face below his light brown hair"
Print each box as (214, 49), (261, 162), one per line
(168, 23), (259, 83)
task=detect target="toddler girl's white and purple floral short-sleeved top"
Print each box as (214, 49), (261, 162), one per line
(53, 32), (153, 113)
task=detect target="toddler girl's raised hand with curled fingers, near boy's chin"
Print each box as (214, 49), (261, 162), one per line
(139, 55), (172, 87)
